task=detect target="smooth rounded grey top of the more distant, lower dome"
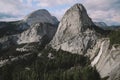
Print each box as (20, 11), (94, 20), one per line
(24, 9), (58, 25)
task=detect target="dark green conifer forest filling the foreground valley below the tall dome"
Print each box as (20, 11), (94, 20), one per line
(0, 48), (100, 80)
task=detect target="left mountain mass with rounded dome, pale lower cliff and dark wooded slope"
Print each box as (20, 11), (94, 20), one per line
(0, 9), (59, 49)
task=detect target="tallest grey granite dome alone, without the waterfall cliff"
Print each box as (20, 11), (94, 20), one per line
(50, 4), (97, 54)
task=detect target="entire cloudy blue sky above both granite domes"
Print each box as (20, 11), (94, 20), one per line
(0, 0), (120, 25)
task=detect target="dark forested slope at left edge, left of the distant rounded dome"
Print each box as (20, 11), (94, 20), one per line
(0, 21), (28, 37)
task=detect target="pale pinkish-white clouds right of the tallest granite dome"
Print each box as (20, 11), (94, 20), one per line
(83, 0), (120, 25)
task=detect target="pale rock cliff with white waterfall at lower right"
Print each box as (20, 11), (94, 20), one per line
(91, 38), (120, 80)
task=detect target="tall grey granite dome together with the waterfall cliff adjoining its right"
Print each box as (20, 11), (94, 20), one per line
(49, 4), (120, 80)
